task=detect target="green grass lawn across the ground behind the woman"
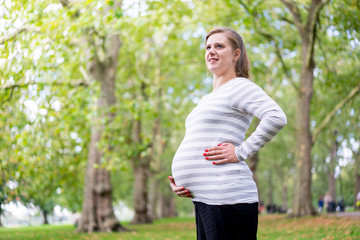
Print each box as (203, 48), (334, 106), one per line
(0, 215), (360, 240)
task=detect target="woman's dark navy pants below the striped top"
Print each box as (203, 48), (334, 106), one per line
(194, 202), (258, 240)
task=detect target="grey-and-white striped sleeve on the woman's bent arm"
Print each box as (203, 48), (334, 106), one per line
(229, 79), (287, 161)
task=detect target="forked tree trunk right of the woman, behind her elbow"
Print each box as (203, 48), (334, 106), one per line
(281, 0), (329, 217)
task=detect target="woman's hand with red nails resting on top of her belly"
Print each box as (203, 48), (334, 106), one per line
(204, 143), (239, 165)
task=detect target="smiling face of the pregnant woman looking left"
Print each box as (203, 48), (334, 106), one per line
(205, 33), (240, 77)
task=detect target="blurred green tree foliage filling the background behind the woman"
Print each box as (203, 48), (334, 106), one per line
(0, 0), (360, 225)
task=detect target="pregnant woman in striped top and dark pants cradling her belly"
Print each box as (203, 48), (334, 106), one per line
(169, 27), (286, 240)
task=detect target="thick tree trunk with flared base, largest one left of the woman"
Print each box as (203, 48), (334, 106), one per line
(77, 30), (126, 232)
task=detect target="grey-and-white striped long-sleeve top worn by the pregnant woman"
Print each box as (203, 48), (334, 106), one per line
(172, 78), (286, 205)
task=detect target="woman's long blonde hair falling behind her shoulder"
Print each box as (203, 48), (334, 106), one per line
(205, 27), (250, 78)
